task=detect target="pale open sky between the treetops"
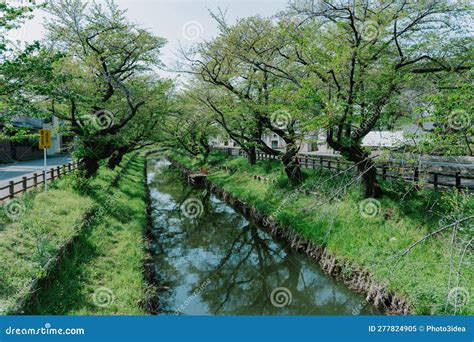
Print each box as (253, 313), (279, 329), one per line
(7, 0), (287, 78)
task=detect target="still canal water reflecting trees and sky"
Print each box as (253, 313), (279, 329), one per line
(148, 158), (381, 315)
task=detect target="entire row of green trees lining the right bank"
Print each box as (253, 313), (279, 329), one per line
(168, 0), (474, 197)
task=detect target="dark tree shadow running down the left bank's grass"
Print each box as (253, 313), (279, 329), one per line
(25, 156), (144, 315)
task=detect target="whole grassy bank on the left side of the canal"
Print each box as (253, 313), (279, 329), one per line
(0, 156), (149, 315)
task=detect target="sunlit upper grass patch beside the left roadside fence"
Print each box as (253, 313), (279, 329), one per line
(0, 189), (93, 313)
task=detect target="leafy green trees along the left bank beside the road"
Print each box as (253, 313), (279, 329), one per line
(0, 0), (173, 177)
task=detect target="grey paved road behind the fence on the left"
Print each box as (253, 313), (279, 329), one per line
(0, 156), (72, 198)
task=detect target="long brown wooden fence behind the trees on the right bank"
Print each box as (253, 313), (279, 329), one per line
(215, 147), (474, 191)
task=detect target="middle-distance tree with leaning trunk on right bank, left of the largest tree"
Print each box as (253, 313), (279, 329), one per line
(183, 16), (312, 183)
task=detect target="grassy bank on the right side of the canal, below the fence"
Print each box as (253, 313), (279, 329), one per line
(172, 152), (474, 314)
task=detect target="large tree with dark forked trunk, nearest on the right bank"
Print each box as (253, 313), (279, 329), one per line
(268, 0), (472, 197)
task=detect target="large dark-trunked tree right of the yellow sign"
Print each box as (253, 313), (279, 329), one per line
(28, 0), (165, 177)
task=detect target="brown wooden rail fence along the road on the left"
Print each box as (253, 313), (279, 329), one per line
(0, 162), (79, 203)
